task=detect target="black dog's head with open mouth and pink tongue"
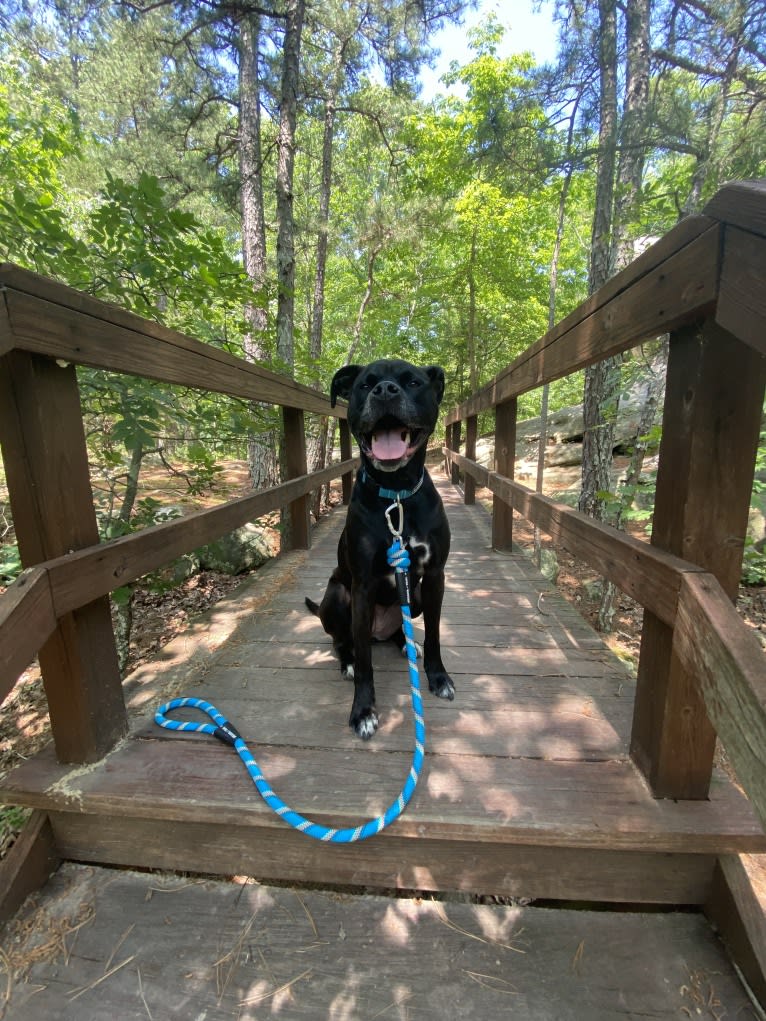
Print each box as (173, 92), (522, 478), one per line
(330, 358), (444, 472)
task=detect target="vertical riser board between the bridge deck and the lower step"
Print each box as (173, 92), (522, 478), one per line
(51, 813), (715, 905)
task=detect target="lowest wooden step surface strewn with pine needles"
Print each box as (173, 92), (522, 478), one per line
(3, 865), (756, 1021)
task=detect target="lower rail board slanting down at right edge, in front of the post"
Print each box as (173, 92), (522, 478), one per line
(674, 575), (766, 827)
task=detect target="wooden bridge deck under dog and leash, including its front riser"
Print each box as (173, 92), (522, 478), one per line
(0, 479), (766, 903)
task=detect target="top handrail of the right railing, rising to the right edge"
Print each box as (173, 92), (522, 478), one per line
(446, 181), (766, 426)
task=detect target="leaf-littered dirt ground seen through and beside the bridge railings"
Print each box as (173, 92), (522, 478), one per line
(0, 461), (766, 858)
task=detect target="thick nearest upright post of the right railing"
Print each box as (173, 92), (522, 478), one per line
(631, 321), (766, 799)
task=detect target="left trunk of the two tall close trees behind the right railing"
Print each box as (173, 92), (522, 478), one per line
(578, 0), (620, 521)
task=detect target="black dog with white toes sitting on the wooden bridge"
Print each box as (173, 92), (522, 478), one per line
(305, 360), (454, 739)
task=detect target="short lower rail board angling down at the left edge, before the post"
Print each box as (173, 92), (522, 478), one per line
(0, 568), (56, 702)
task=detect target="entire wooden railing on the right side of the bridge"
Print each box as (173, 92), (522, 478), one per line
(444, 175), (766, 826)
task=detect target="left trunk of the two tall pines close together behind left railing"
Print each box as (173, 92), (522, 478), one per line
(239, 14), (278, 489)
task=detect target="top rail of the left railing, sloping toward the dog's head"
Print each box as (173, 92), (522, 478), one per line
(0, 263), (345, 417)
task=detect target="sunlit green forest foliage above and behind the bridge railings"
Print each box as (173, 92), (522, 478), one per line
(0, 0), (766, 588)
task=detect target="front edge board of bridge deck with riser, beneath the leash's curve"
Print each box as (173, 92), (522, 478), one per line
(2, 735), (766, 904)
